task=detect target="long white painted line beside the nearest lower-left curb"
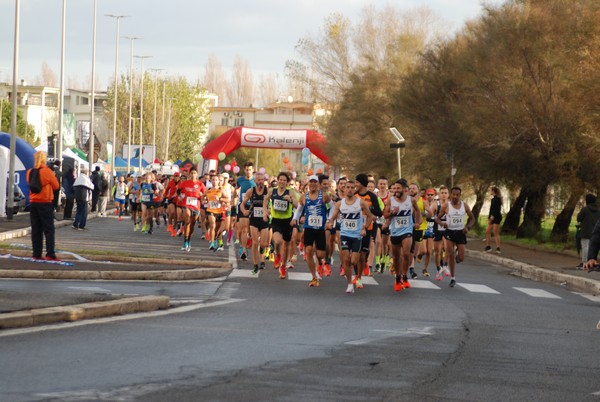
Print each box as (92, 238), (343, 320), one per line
(0, 299), (245, 338)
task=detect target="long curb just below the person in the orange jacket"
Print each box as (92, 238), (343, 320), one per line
(0, 268), (232, 281)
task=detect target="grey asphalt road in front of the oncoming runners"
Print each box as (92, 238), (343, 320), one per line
(0, 250), (600, 401)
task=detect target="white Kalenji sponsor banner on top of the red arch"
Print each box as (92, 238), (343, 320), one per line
(241, 127), (306, 149)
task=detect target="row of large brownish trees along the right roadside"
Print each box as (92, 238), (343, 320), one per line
(288, 0), (600, 240)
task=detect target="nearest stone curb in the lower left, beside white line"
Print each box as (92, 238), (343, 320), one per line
(0, 296), (170, 329)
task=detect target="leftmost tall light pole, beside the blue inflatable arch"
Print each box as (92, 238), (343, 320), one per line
(2, 0), (21, 220)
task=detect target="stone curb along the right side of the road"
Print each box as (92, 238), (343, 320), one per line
(465, 249), (600, 295)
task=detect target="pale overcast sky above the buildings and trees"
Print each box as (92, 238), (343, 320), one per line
(0, 0), (501, 90)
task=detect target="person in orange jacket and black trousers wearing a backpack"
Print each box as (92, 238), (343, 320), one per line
(27, 151), (59, 261)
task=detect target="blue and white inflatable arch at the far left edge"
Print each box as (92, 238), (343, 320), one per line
(0, 133), (35, 206)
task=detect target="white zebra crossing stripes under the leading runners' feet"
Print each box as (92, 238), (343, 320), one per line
(229, 269), (600, 303)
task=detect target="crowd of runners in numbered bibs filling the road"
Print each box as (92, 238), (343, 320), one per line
(113, 162), (475, 294)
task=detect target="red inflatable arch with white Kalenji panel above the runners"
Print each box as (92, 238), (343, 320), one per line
(201, 127), (329, 172)
